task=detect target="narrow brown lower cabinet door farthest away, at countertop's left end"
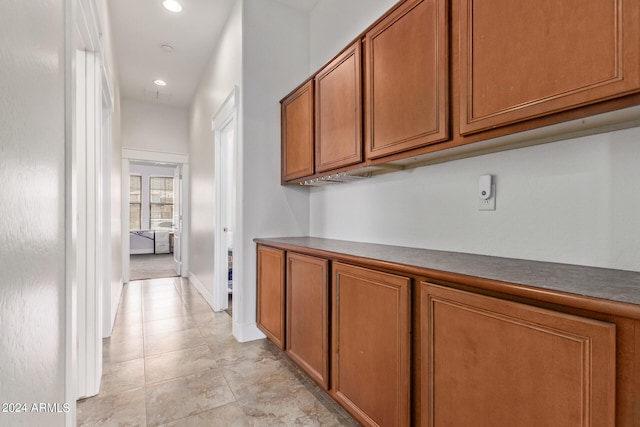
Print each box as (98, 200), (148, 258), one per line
(256, 246), (285, 349)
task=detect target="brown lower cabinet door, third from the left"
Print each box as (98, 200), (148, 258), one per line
(332, 263), (410, 426)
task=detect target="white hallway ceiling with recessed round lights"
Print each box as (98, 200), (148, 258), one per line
(108, 0), (319, 108)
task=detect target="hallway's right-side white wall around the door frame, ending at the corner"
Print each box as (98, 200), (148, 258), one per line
(186, 1), (242, 308)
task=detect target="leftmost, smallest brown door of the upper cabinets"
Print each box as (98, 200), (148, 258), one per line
(281, 80), (315, 182)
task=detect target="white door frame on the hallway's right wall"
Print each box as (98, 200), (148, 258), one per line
(211, 86), (242, 318)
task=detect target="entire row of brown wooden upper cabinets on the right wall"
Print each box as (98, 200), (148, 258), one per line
(281, 0), (640, 183)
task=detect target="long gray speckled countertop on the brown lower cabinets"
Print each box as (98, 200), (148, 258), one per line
(255, 237), (640, 305)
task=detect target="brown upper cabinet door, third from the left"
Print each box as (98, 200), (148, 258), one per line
(364, 0), (449, 159)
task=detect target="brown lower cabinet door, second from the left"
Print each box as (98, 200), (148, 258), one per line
(286, 252), (329, 390)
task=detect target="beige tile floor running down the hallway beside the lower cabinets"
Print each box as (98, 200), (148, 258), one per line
(77, 277), (358, 427)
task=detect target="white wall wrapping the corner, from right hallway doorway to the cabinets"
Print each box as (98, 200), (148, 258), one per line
(189, 0), (309, 340)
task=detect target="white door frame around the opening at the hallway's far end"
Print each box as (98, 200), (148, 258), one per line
(122, 148), (189, 283)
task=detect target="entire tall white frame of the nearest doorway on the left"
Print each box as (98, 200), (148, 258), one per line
(65, 0), (114, 426)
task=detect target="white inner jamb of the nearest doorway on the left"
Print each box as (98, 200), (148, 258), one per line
(72, 50), (104, 397)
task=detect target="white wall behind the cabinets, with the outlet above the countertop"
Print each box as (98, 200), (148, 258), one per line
(310, 0), (640, 271)
